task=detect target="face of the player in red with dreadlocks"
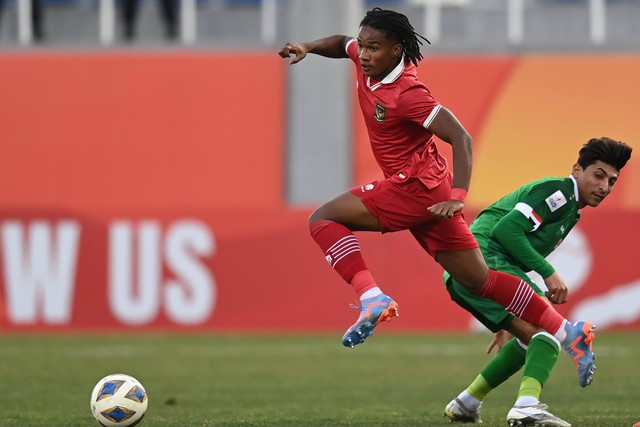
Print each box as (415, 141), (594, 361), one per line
(358, 26), (402, 81)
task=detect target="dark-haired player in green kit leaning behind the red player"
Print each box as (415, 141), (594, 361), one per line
(444, 137), (632, 427)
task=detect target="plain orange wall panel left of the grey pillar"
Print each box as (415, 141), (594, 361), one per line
(0, 53), (285, 215)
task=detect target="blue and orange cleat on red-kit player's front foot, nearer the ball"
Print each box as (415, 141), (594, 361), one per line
(342, 294), (398, 348)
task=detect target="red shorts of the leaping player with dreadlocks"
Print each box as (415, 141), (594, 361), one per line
(349, 174), (478, 258)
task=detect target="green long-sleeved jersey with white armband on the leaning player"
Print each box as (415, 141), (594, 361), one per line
(470, 176), (580, 278)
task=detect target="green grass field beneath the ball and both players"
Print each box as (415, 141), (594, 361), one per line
(0, 331), (640, 427)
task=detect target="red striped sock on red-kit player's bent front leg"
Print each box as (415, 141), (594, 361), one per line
(309, 220), (376, 296)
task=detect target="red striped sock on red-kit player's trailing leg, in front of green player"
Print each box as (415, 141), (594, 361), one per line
(479, 270), (564, 335)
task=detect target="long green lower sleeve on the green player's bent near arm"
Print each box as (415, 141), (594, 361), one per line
(491, 210), (555, 279)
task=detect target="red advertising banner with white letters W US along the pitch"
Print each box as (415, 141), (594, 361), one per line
(0, 210), (640, 331)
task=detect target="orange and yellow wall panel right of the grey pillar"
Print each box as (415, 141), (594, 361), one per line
(354, 55), (640, 209)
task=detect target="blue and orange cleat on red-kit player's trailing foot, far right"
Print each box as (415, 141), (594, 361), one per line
(562, 322), (596, 387)
